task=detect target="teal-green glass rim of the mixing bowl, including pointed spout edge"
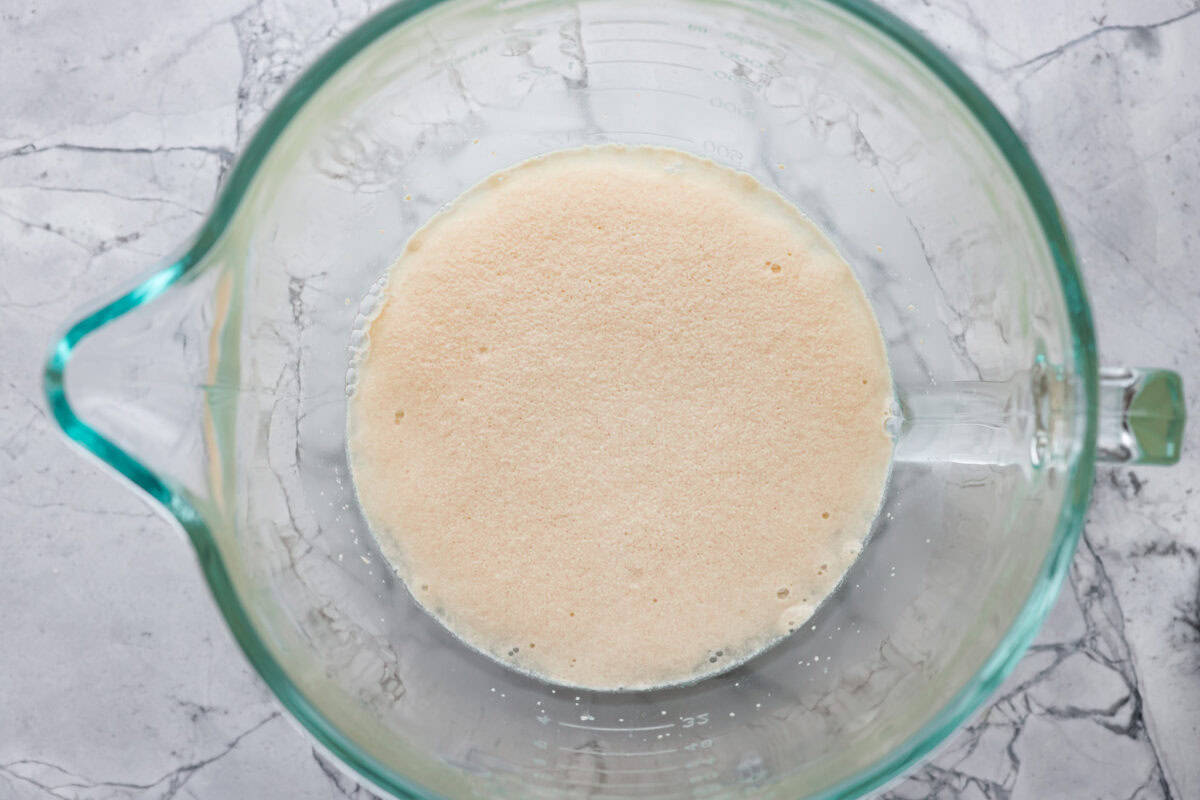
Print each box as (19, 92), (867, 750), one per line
(43, 0), (1098, 800)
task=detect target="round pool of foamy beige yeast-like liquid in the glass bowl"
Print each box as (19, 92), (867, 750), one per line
(349, 146), (892, 688)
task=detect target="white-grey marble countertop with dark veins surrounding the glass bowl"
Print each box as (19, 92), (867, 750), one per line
(0, 0), (1200, 800)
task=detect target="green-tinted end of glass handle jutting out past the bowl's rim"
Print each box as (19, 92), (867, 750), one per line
(1096, 367), (1187, 464)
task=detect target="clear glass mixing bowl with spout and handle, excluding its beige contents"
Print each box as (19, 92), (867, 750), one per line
(46, 0), (1182, 799)
